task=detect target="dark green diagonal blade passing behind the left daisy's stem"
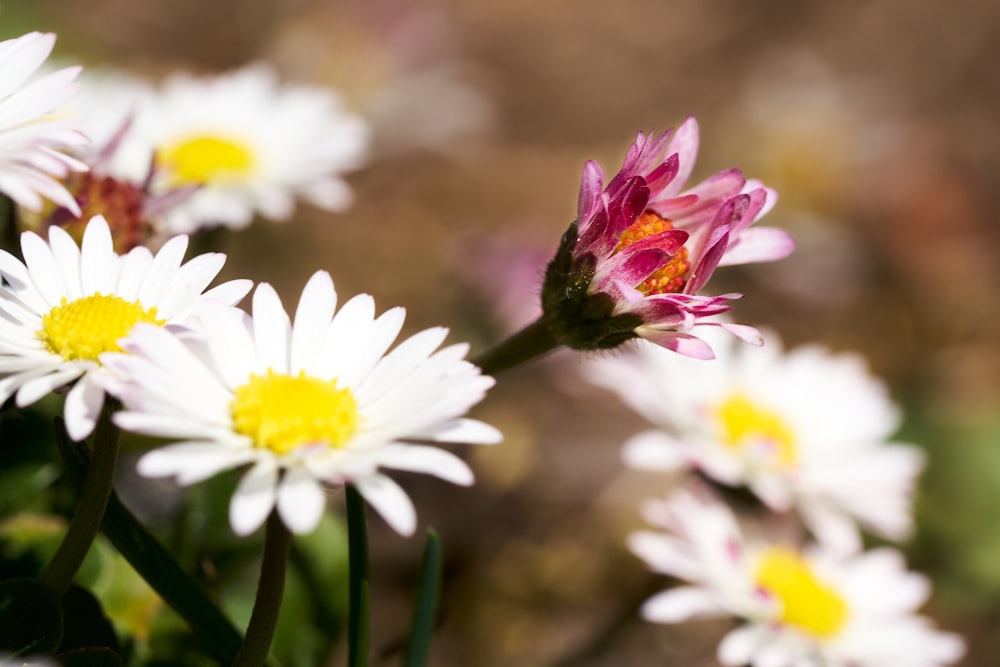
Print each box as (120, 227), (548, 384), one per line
(56, 419), (242, 664)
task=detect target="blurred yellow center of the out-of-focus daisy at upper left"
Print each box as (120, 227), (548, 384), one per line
(161, 136), (254, 185)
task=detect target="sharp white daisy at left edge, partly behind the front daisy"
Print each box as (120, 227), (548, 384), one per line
(0, 216), (251, 440)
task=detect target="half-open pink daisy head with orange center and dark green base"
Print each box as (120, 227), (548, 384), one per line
(543, 118), (793, 358)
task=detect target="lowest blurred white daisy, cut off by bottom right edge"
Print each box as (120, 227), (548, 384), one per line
(629, 493), (964, 667)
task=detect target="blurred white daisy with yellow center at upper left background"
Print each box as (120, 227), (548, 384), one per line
(113, 65), (369, 234)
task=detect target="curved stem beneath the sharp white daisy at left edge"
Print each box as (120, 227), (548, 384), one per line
(41, 398), (121, 596)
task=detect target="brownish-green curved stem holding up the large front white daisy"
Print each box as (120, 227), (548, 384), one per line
(233, 511), (292, 667)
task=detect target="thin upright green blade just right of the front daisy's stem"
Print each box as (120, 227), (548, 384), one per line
(345, 484), (371, 667)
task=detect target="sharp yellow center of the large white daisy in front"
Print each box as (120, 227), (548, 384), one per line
(230, 369), (360, 455)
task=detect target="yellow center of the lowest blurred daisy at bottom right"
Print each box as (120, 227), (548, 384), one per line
(754, 547), (849, 639)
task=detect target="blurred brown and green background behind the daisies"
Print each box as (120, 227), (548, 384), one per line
(0, 0), (1000, 667)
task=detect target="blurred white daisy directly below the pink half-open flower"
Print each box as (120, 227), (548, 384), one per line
(587, 332), (923, 553)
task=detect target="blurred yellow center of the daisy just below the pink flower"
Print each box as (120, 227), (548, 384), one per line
(716, 393), (797, 468)
